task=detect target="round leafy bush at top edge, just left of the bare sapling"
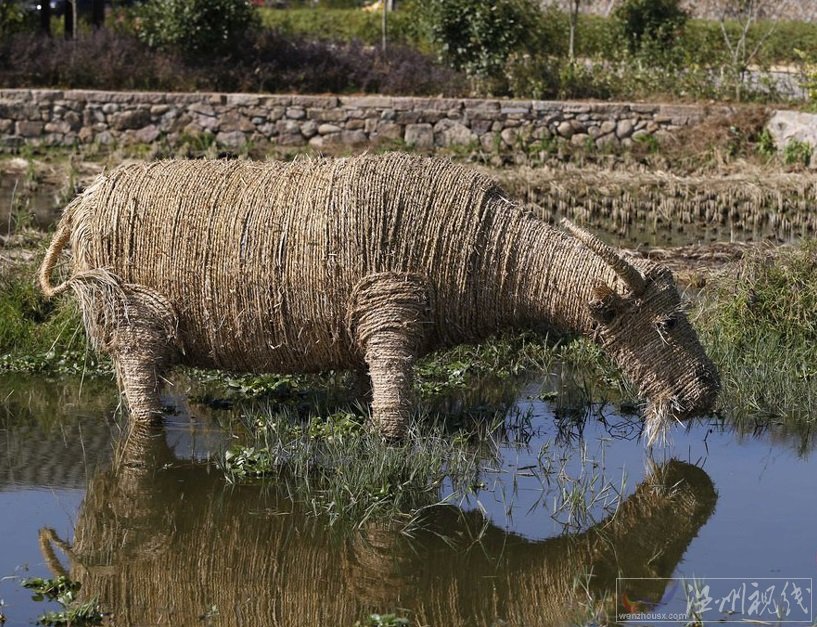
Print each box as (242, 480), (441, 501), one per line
(613, 0), (689, 54)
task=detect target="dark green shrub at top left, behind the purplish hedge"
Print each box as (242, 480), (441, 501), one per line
(137, 0), (258, 57)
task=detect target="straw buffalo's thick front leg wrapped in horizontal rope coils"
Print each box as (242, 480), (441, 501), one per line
(348, 272), (429, 439)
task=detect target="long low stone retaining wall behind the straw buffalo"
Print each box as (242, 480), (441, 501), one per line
(0, 89), (731, 150)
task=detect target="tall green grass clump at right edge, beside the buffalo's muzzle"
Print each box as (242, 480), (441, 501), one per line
(698, 240), (817, 446)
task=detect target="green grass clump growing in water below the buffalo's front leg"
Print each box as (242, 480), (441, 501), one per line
(223, 410), (491, 530)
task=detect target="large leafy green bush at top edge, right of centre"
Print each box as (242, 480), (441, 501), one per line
(424, 0), (542, 79)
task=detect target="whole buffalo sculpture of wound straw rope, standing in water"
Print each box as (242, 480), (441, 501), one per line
(39, 154), (719, 441)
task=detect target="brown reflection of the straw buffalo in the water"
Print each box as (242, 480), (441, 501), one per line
(41, 426), (716, 625)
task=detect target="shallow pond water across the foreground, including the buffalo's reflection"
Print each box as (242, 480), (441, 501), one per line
(0, 379), (817, 625)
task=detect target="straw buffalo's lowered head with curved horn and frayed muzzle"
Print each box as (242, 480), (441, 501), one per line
(563, 221), (720, 444)
